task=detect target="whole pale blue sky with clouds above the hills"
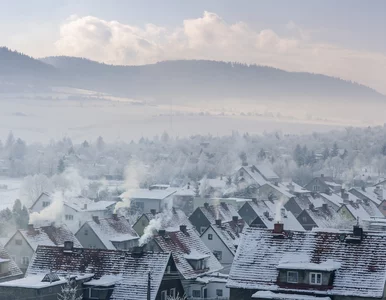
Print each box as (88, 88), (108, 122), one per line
(0, 0), (386, 94)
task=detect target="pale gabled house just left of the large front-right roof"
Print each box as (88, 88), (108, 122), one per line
(201, 216), (249, 274)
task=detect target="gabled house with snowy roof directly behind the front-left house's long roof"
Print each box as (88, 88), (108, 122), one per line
(75, 214), (139, 250)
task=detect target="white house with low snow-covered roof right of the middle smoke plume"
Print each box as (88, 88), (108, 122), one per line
(120, 185), (177, 213)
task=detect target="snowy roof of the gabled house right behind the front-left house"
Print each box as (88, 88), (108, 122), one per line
(83, 217), (139, 250)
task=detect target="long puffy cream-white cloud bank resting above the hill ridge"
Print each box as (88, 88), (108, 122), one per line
(55, 12), (386, 94)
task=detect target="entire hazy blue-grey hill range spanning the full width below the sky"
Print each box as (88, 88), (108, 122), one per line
(0, 48), (386, 102)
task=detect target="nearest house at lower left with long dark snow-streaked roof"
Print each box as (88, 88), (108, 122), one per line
(6, 242), (184, 300)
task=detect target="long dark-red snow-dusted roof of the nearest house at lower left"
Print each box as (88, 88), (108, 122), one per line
(27, 246), (170, 300)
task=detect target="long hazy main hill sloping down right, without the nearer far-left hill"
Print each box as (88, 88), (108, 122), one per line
(42, 57), (386, 100)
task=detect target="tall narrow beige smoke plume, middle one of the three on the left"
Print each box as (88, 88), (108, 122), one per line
(114, 160), (145, 213)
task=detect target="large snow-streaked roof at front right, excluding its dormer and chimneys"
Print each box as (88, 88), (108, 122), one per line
(227, 227), (386, 298)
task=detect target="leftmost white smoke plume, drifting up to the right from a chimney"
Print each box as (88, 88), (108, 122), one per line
(30, 168), (87, 226)
